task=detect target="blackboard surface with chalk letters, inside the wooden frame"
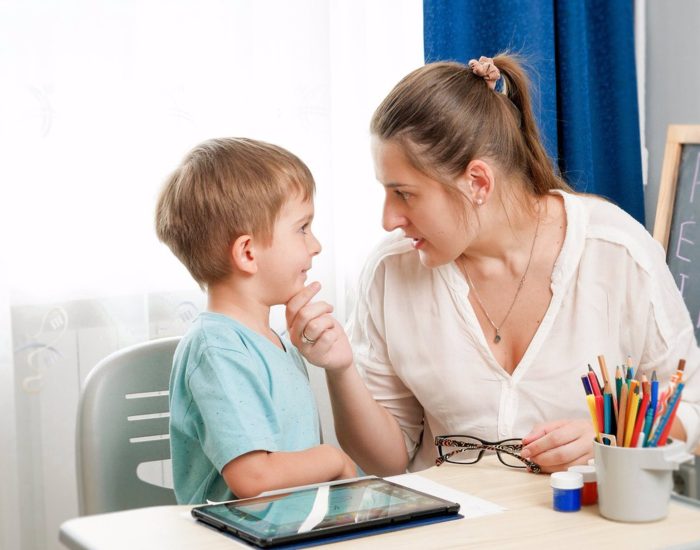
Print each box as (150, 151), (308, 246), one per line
(666, 144), (700, 342)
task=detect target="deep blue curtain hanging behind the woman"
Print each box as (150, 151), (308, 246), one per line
(423, 0), (644, 224)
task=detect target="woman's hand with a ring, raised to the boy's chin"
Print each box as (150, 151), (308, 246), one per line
(286, 282), (352, 370)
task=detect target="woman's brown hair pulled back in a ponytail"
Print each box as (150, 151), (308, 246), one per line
(370, 54), (571, 196)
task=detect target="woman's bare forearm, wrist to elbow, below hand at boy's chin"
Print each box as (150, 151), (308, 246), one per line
(326, 365), (408, 476)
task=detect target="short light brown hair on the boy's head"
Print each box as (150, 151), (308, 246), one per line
(156, 138), (315, 288)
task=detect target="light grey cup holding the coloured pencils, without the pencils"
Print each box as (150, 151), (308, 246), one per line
(593, 439), (693, 522)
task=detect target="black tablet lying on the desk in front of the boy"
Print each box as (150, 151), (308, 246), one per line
(192, 477), (459, 547)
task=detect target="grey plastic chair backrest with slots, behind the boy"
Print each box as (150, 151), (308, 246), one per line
(76, 337), (180, 515)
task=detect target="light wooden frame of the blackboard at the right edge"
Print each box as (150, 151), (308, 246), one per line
(654, 124), (700, 248)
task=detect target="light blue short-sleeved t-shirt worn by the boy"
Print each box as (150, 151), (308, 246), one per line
(170, 312), (320, 504)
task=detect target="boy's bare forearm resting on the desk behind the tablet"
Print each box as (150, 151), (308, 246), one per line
(221, 445), (357, 498)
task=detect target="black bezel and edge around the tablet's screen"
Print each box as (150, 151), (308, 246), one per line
(192, 477), (460, 548)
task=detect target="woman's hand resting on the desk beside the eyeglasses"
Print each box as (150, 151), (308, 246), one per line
(520, 420), (595, 473)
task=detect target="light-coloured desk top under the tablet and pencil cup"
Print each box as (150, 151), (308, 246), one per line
(60, 457), (700, 550)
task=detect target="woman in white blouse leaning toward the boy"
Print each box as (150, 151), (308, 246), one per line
(288, 55), (700, 475)
